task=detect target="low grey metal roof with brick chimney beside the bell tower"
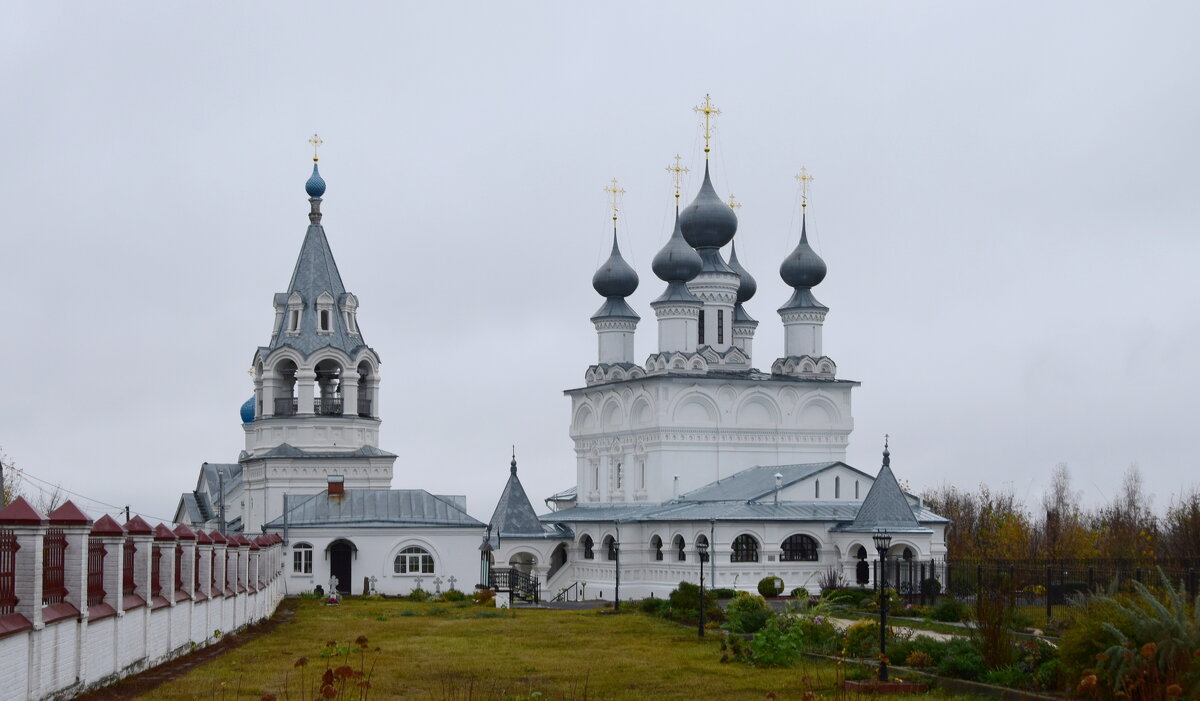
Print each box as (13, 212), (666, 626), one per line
(263, 490), (484, 528)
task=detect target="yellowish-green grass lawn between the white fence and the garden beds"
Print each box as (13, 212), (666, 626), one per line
(140, 599), (984, 701)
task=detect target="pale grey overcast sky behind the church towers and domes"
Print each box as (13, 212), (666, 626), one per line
(0, 2), (1200, 519)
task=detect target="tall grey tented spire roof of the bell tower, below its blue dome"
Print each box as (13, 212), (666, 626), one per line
(268, 207), (365, 358)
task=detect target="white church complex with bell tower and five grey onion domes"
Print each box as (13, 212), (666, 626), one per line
(175, 124), (947, 599)
